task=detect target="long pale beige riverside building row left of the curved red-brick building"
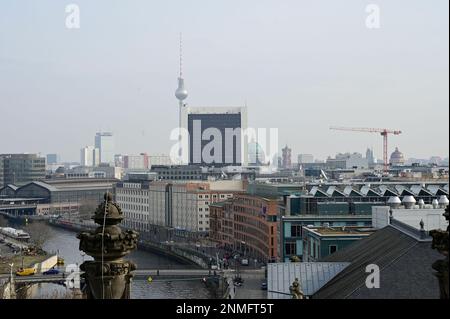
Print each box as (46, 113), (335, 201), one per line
(115, 180), (243, 237)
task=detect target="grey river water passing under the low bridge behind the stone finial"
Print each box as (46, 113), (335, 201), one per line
(7, 220), (213, 299)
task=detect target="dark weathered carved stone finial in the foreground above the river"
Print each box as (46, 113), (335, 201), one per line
(77, 193), (138, 299)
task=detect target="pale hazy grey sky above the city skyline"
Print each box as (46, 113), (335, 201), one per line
(0, 0), (449, 161)
